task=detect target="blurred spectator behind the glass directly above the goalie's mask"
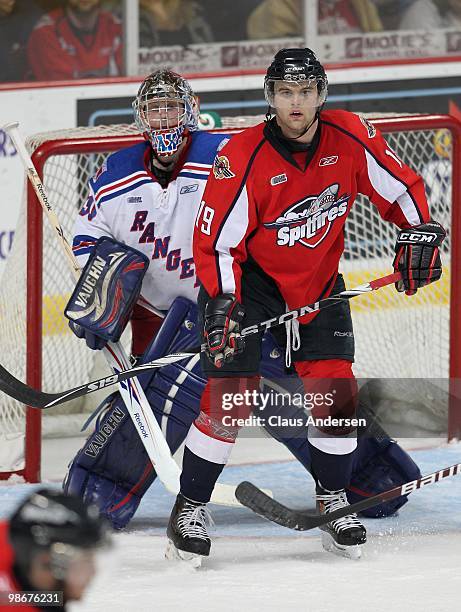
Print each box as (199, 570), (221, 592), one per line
(139, 0), (213, 47)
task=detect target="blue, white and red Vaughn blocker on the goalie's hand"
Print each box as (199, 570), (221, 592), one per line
(64, 236), (149, 350)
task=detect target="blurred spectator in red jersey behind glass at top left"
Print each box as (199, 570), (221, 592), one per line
(27, 0), (123, 81)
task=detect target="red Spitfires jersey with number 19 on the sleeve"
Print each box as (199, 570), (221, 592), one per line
(194, 110), (429, 323)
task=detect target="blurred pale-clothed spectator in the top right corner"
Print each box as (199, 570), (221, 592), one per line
(400, 0), (461, 30)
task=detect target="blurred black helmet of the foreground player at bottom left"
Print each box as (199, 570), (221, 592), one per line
(9, 488), (109, 552)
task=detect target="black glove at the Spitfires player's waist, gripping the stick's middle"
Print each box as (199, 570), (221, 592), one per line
(204, 293), (245, 368)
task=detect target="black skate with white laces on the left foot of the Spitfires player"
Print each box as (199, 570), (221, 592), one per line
(165, 493), (212, 568)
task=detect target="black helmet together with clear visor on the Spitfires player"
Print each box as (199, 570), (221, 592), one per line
(264, 48), (328, 109)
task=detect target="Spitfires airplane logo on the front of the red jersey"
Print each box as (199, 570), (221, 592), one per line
(264, 183), (350, 249)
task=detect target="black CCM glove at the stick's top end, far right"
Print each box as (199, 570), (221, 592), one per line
(393, 221), (446, 295)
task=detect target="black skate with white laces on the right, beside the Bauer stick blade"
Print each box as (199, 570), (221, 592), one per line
(317, 486), (367, 559)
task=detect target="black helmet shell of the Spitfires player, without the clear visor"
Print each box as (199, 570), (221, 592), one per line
(264, 47), (328, 107)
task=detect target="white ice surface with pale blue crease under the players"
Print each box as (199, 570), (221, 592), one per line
(0, 440), (461, 612)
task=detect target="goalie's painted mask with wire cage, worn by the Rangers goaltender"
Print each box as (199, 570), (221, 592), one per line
(133, 70), (198, 157)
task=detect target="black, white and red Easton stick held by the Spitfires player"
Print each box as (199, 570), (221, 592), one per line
(0, 273), (401, 410)
